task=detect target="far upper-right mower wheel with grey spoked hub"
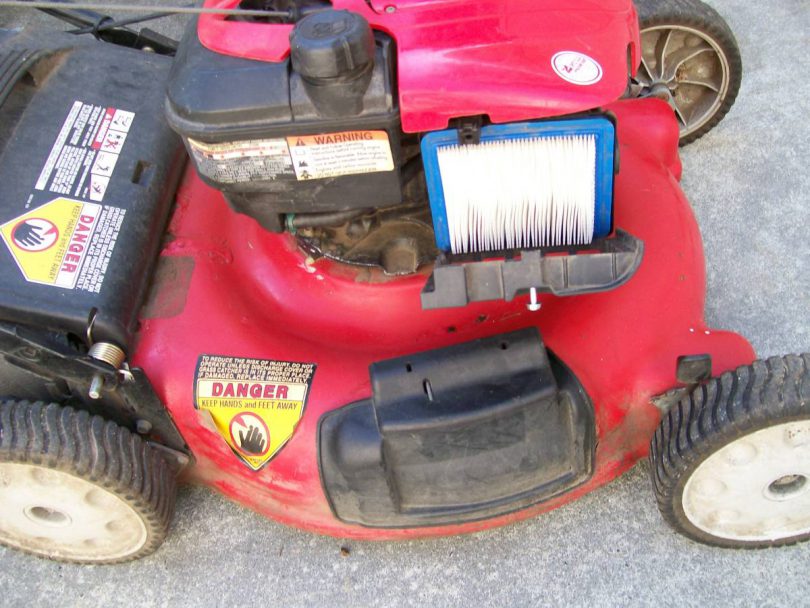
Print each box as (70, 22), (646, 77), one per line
(632, 0), (742, 145)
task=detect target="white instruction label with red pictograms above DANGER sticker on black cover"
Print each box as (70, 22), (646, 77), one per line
(34, 101), (135, 202)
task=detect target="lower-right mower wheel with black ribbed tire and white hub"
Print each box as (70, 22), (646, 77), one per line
(649, 354), (810, 548)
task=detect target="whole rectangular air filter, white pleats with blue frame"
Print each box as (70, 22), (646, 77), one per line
(422, 117), (615, 253)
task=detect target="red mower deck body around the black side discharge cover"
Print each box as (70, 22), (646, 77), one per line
(133, 100), (754, 538)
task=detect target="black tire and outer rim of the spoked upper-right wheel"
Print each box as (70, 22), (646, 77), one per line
(635, 0), (743, 146)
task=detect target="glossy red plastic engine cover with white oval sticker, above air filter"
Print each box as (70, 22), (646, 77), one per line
(198, 0), (638, 133)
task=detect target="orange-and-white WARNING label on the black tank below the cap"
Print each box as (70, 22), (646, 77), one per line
(287, 131), (394, 180)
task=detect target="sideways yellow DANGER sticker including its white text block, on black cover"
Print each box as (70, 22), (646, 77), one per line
(0, 198), (125, 293)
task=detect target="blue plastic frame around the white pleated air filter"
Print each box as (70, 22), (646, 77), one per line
(422, 117), (616, 251)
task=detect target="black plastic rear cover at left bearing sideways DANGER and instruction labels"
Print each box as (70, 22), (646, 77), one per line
(0, 31), (184, 348)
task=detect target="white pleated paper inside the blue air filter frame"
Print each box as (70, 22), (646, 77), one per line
(437, 135), (596, 253)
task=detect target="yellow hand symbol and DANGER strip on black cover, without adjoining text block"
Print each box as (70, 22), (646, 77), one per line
(0, 198), (102, 289)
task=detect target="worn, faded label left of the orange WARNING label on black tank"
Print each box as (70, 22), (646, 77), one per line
(188, 138), (295, 184)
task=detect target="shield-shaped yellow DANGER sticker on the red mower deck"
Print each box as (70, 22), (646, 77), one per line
(194, 355), (315, 471)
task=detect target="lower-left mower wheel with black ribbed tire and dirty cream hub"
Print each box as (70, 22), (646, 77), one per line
(0, 401), (176, 564)
